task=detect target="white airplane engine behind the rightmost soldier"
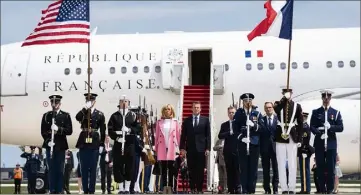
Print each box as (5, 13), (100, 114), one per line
(298, 99), (360, 174)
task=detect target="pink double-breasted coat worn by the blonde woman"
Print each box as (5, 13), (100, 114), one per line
(155, 119), (180, 160)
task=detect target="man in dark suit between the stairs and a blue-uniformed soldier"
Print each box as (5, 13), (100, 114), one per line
(218, 106), (242, 194)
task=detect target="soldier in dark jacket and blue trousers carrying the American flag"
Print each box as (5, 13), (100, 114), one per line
(75, 93), (106, 194)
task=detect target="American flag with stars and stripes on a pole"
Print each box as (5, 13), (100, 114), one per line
(21, 0), (90, 47)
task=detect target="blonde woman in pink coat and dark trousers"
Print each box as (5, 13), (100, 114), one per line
(155, 104), (180, 192)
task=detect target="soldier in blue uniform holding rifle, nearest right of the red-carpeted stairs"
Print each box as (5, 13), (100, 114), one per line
(234, 93), (264, 194)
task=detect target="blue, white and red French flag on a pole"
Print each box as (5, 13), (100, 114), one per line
(247, 0), (294, 41)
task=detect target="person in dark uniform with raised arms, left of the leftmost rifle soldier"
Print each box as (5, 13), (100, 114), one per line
(21, 147), (41, 194)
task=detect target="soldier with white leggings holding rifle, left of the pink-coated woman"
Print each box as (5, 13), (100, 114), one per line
(108, 97), (140, 194)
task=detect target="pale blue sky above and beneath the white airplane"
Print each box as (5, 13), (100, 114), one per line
(1, 1), (360, 166)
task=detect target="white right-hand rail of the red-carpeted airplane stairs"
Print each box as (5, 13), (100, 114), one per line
(207, 62), (215, 188)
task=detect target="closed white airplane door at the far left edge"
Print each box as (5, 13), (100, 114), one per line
(1, 53), (30, 96)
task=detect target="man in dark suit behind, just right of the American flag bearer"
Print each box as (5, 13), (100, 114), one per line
(99, 135), (113, 194)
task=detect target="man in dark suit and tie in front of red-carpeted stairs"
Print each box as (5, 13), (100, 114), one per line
(179, 101), (211, 193)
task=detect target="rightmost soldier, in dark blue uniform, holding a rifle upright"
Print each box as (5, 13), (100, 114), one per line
(310, 90), (343, 194)
